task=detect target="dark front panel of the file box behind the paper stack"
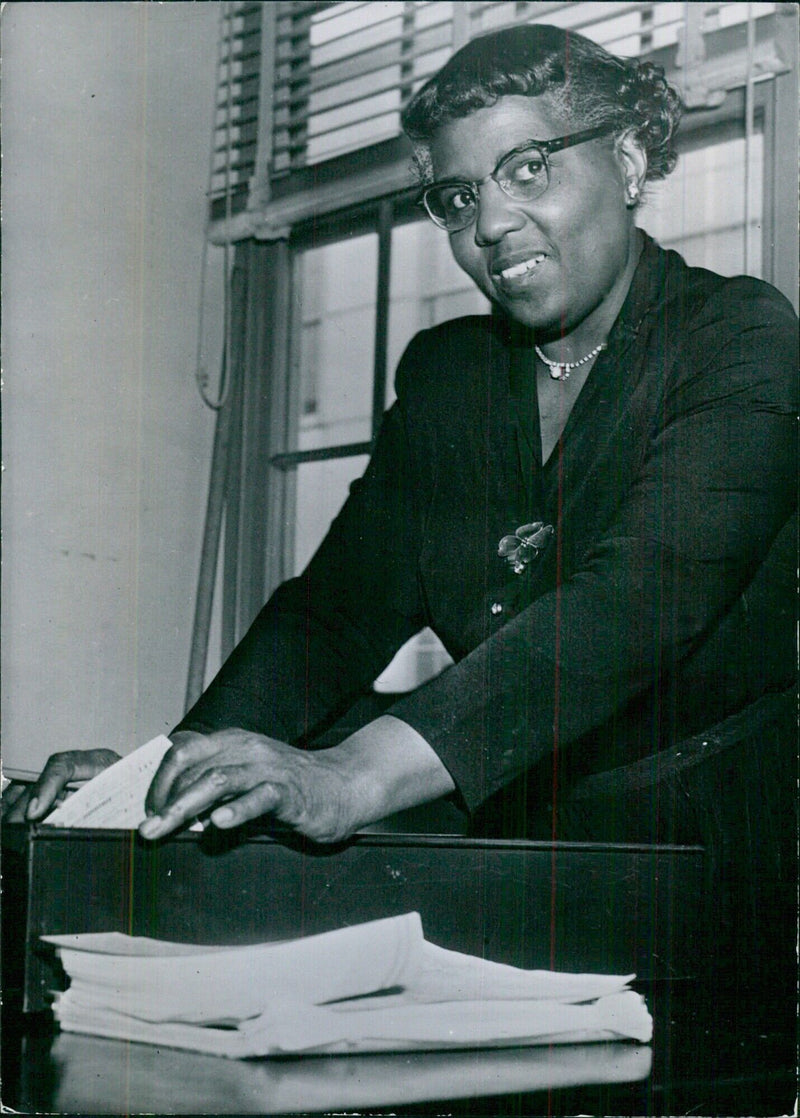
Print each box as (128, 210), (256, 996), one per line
(7, 826), (705, 1012)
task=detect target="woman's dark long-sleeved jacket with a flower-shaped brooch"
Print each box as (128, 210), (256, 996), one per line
(180, 239), (798, 831)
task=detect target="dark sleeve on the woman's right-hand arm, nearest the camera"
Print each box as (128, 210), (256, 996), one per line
(391, 280), (797, 808)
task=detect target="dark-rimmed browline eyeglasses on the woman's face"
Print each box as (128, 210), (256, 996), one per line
(419, 124), (613, 233)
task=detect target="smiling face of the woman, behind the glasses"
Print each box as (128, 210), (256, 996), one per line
(430, 96), (644, 345)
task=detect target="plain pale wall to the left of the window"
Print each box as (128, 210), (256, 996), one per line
(2, 2), (218, 770)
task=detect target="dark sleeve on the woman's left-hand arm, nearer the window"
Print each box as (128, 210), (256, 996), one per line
(175, 344), (425, 742)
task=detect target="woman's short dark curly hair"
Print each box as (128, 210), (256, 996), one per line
(402, 23), (683, 181)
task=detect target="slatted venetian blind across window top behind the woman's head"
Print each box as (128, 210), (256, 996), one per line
(211, 0), (779, 216)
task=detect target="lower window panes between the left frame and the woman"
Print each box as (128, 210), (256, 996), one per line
(282, 213), (489, 572)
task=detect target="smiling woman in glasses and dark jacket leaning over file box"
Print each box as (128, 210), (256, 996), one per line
(9, 26), (797, 872)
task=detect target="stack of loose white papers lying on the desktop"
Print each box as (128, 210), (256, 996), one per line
(44, 912), (653, 1058)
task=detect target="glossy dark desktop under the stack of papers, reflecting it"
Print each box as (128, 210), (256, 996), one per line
(3, 983), (797, 1118)
